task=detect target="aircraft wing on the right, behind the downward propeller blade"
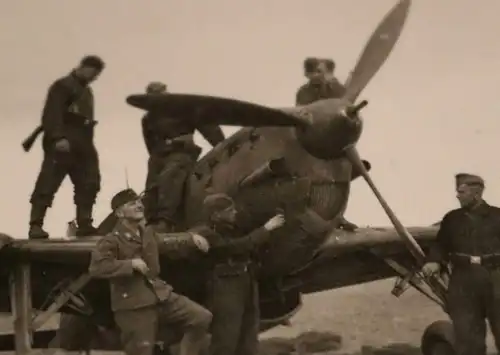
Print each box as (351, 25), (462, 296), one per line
(291, 225), (439, 300)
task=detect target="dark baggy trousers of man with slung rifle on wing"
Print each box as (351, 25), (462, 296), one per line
(30, 142), (101, 208)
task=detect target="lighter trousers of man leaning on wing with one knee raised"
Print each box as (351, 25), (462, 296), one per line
(115, 292), (212, 355)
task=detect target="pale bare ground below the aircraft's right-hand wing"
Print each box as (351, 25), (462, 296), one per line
(0, 280), (494, 355)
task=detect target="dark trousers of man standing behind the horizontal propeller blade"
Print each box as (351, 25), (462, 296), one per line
(144, 151), (196, 224)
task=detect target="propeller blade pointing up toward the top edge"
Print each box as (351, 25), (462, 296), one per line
(344, 0), (411, 103)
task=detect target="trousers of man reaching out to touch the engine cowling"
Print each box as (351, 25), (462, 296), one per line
(209, 272), (260, 355)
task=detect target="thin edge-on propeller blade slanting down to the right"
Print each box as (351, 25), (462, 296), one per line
(346, 146), (425, 266)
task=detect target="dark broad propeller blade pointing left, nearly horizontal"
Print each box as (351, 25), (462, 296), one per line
(127, 93), (308, 127)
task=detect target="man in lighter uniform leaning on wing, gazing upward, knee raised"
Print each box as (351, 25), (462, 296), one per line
(89, 189), (212, 355)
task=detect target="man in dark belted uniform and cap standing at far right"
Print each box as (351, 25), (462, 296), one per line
(423, 174), (500, 355)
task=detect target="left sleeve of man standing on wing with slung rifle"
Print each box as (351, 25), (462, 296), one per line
(42, 82), (71, 140)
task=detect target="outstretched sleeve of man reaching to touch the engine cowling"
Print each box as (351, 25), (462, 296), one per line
(206, 227), (271, 257)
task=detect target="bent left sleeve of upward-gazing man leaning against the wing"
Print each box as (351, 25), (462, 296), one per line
(89, 235), (134, 279)
